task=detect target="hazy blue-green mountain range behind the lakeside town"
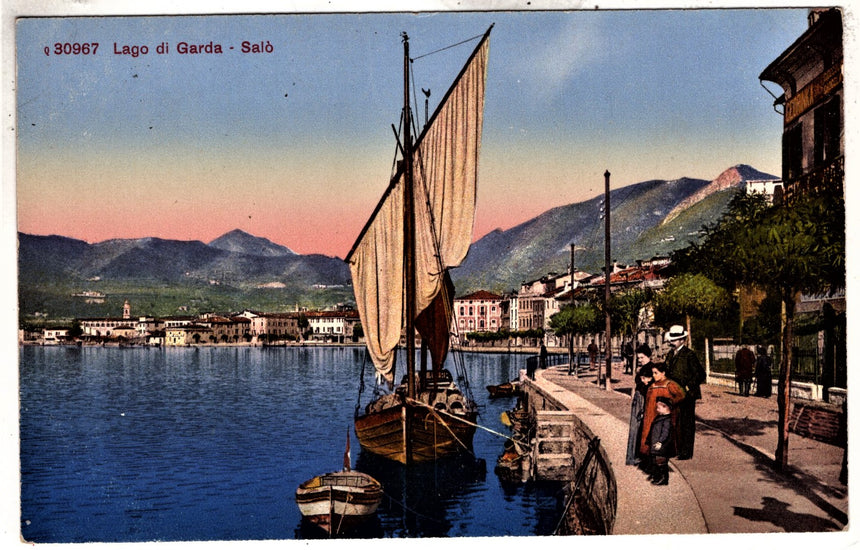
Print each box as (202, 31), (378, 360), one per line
(18, 165), (777, 318)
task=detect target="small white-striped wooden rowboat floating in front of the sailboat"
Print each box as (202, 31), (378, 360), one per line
(296, 471), (383, 535)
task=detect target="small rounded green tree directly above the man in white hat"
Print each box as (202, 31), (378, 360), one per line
(657, 273), (733, 348)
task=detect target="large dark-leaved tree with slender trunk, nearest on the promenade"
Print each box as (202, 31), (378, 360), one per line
(673, 195), (845, 469)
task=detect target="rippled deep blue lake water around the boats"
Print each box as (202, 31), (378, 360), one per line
(20, 346), (564, 543)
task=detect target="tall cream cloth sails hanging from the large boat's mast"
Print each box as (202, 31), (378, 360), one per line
(347, 34), (489, 382)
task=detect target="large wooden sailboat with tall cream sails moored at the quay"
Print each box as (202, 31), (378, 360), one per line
(346, 26), (492, 464)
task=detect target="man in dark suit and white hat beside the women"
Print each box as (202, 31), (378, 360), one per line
(665, 325), (706, 460)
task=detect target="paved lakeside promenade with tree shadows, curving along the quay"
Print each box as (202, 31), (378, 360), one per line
(535, 366), (850, 542)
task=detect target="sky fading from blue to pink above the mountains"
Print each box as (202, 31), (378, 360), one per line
(16, 8), (807, 258)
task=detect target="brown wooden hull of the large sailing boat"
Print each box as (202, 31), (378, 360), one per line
(355, 404), (477, 464)
